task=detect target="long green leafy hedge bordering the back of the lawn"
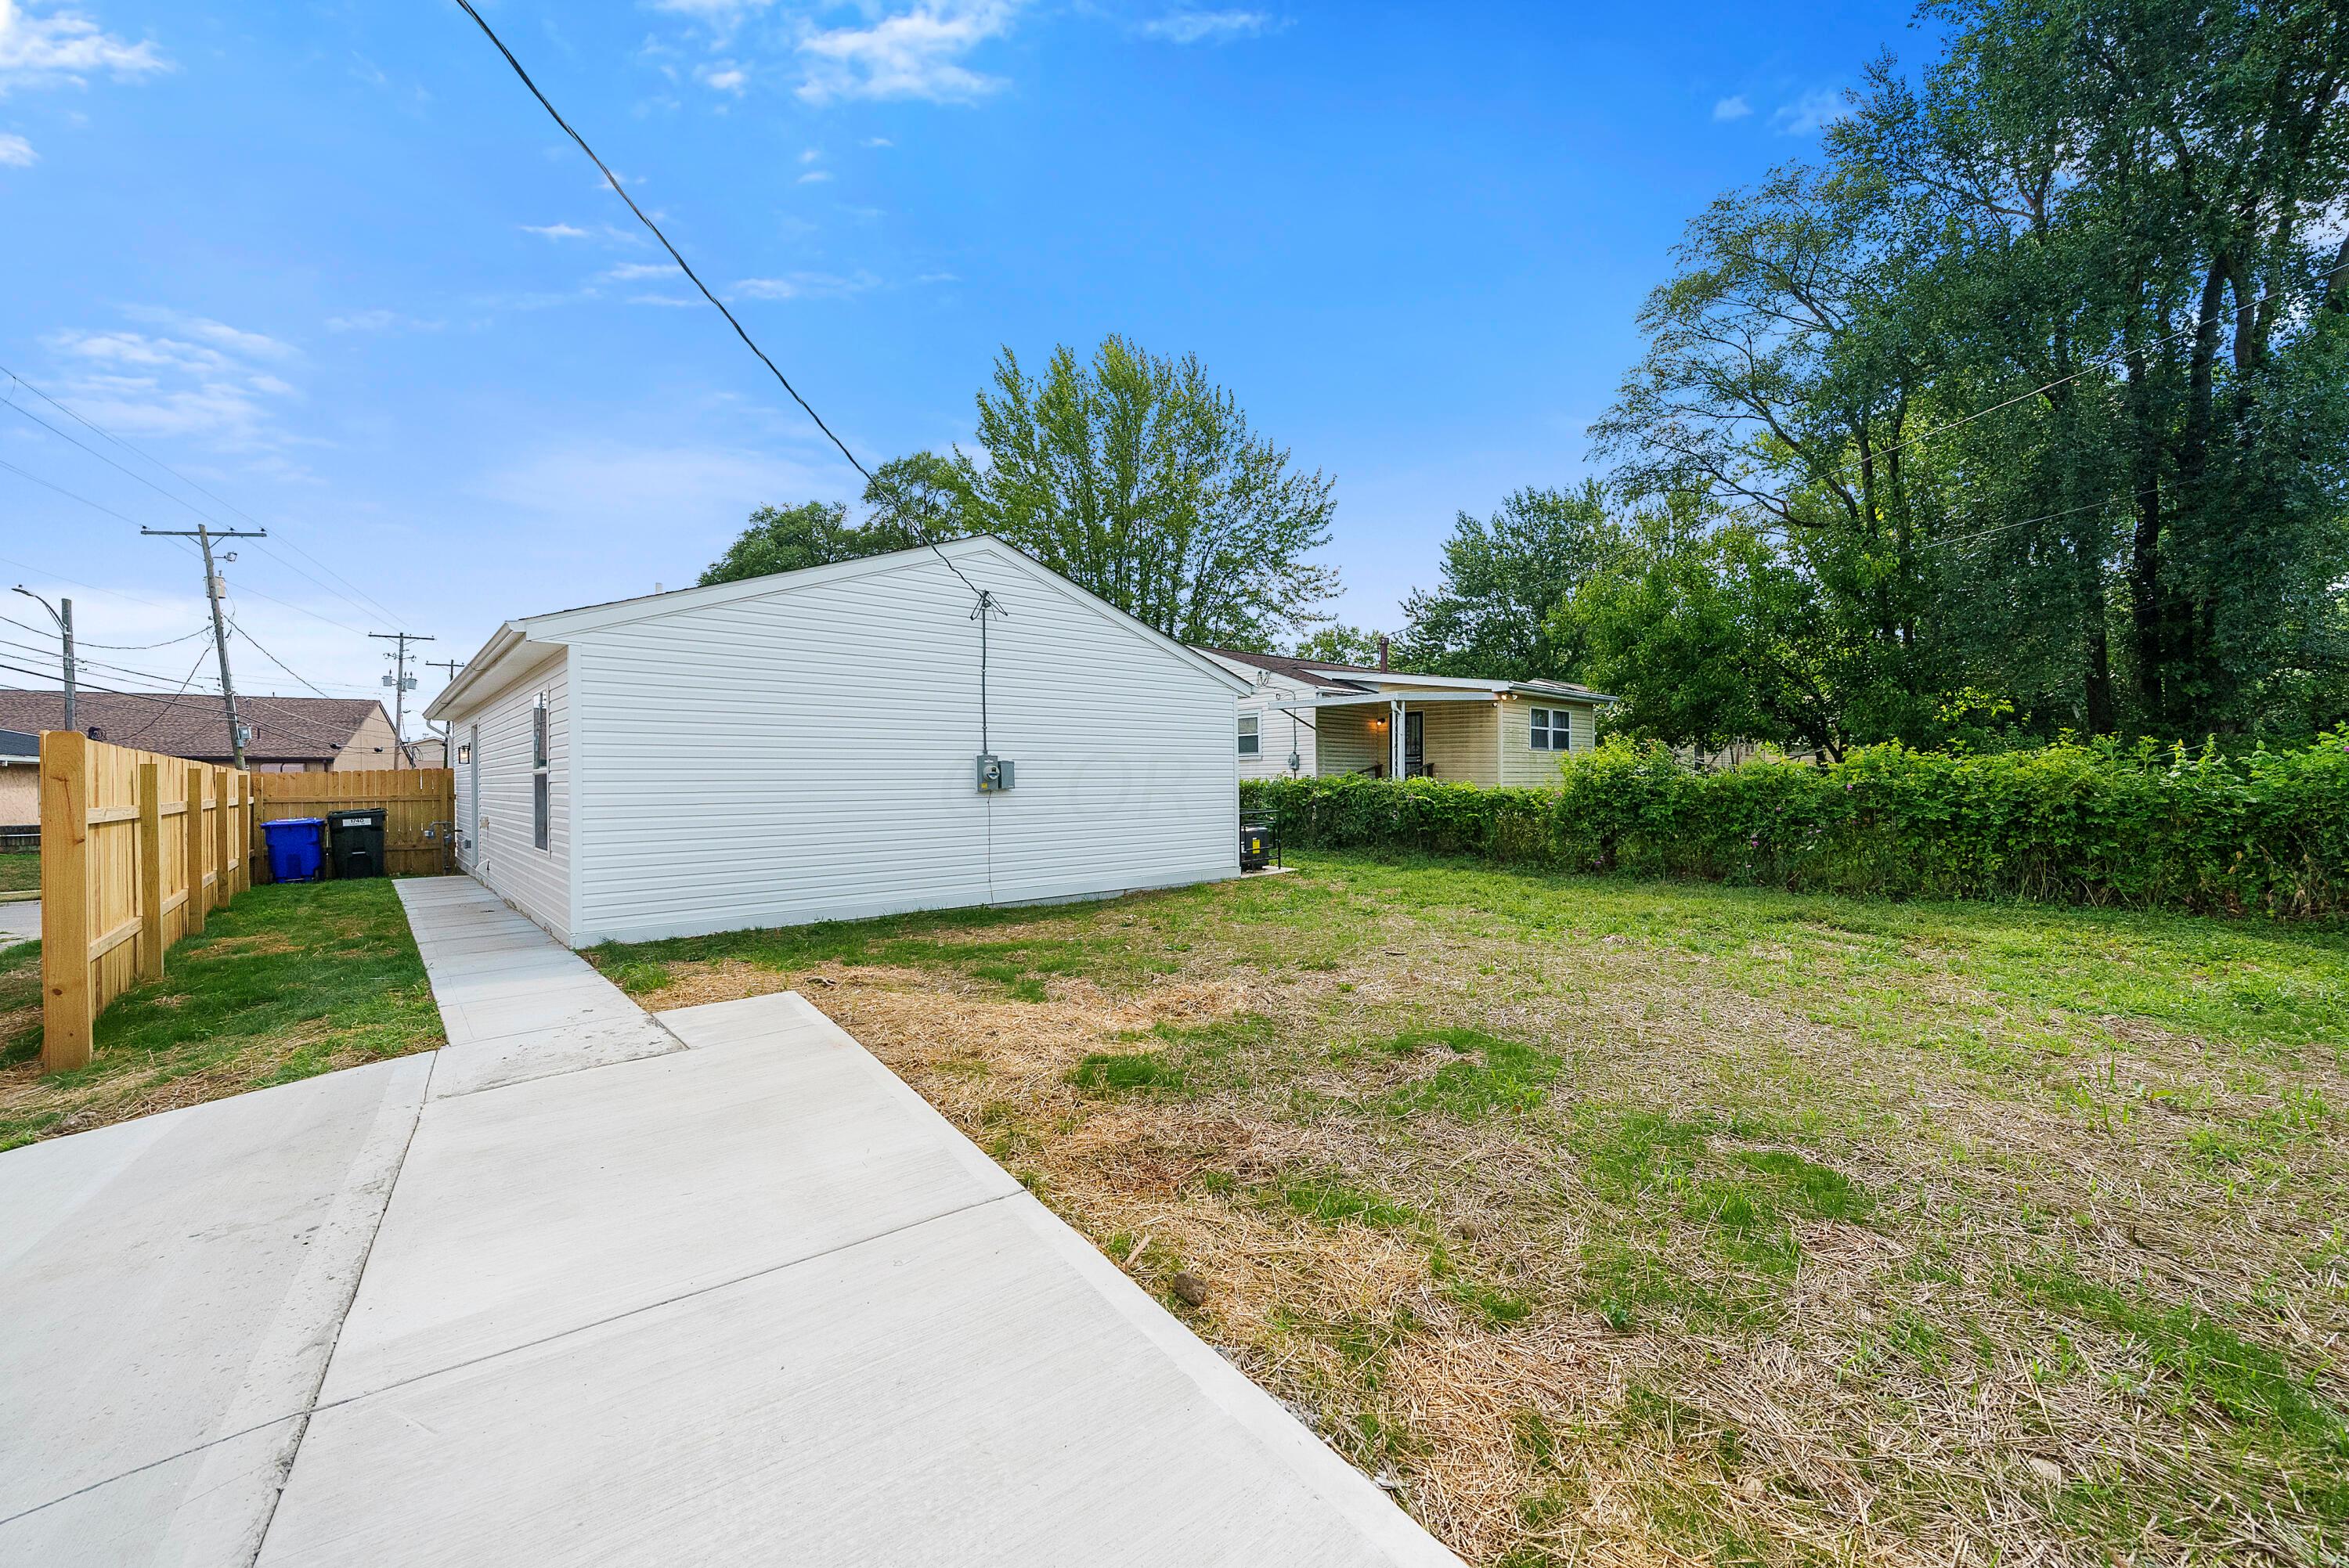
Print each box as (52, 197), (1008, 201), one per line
(1240, 733), (2349, 915)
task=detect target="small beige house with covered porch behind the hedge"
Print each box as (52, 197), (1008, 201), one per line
(1200, 648), (1614, 784)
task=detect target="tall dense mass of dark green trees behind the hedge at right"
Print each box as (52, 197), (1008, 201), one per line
(1590, 0), (2349, 744)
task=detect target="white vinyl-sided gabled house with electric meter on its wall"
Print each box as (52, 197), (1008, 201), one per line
(425, 535), (1250, 946)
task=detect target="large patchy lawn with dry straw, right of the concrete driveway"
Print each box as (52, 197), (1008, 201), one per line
(594, 854), (2349, 1568)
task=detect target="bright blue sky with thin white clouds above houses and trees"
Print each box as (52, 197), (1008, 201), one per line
(0, 0), (1926, 732)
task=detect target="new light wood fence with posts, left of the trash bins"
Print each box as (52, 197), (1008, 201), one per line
(40, 730), (254, 1070)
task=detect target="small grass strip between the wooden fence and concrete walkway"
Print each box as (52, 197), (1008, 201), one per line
(0, 878), (442, 1148)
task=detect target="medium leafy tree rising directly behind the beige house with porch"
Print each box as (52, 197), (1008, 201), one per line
(1400, 484), (1614, 681)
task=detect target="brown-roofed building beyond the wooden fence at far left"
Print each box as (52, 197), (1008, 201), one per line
(0, 690), (404, 773)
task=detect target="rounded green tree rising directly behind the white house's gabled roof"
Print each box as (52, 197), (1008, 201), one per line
(944, 338), (1337, 648)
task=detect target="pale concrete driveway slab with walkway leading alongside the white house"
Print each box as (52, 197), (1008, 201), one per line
(0, 878), (1456, 1568)
